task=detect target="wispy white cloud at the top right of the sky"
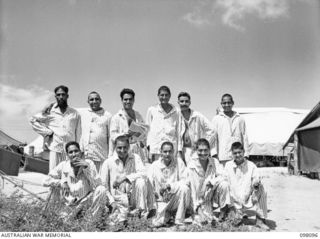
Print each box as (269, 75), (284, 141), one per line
(182, 0), (289, 31)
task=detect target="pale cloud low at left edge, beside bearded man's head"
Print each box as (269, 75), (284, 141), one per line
(0, 83), (53, 119)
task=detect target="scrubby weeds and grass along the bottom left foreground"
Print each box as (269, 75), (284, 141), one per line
(0, 192), (261, 232)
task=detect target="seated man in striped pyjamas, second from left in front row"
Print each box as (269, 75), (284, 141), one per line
(100, 135), (155, 222)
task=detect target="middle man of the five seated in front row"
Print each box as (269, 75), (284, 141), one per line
(148, 141), (191, 227)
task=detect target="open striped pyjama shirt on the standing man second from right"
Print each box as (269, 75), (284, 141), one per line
(178, 110), (215, 151)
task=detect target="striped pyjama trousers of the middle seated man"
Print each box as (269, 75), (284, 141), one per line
(152, 183), (191, 225)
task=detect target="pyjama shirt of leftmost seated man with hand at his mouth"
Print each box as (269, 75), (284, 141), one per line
(43, 159), (112, 203)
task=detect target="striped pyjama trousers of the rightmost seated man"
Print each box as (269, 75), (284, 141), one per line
(231, 184), (268, 219)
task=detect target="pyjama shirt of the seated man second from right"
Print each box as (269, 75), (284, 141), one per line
(187, 155), (226, 209)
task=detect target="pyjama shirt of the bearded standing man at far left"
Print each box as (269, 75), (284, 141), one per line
(30, 103), (81, 153)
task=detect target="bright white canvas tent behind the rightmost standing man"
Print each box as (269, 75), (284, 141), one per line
(235, 107), (308, 156)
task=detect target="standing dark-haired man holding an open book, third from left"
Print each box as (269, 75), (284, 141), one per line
(109, 88), (148, 161)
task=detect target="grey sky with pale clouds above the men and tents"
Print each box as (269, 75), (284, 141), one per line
(0, 0), (320, 142)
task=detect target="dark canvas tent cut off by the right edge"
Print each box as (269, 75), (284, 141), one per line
(284, 102), (320, 172)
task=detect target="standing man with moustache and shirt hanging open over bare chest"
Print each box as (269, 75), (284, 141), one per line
(178, 92), (215, 164)
